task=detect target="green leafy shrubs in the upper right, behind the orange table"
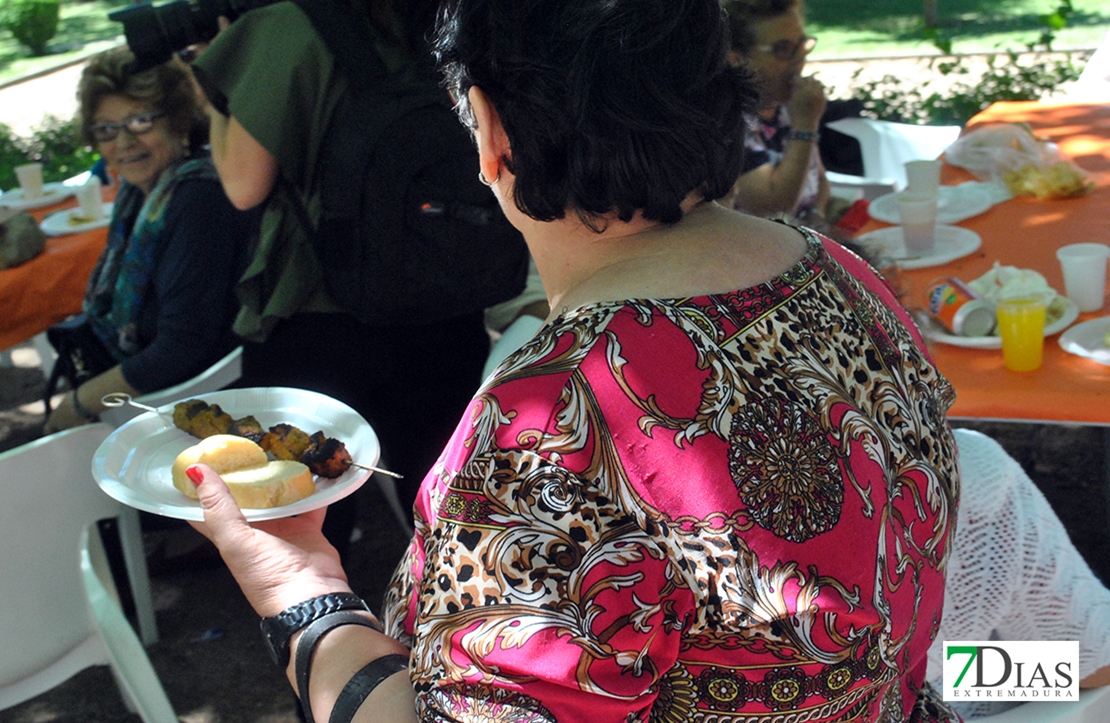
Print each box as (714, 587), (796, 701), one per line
(854, 0), (1086, 125)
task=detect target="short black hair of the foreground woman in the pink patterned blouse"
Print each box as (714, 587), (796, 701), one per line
(434, 0), (757, 228)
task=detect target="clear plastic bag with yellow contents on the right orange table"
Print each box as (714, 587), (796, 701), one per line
(945, 123), (1094, 199)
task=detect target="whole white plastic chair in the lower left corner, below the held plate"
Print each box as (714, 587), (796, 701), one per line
(0, 424), (176, 722)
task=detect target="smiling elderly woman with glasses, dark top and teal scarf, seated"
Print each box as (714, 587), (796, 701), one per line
(46, 48), (256, 432)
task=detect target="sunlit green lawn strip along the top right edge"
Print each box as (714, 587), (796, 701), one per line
(806, 0), (1110, 60)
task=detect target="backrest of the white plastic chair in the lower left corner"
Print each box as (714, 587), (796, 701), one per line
(0, 424), (120, 710)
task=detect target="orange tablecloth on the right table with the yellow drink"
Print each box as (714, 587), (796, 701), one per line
(862, 102), (1110, 425)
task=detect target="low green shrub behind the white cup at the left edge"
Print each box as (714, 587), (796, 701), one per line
(0, 118), (99, 189)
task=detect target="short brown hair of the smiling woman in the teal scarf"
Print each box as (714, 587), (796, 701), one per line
(77, 46), (208, 149)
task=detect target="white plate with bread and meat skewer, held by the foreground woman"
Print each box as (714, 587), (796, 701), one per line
(92, 386), (381, 522)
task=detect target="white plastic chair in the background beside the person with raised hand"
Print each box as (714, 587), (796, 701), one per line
(828, 118), (961, 200)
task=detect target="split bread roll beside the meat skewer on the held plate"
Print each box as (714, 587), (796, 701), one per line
(171, 434), (316, 509)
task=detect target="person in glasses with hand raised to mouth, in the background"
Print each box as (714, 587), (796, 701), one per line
(723, 0), (829, 230)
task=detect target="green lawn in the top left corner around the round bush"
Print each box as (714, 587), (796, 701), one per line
(0, 0), (130, 84)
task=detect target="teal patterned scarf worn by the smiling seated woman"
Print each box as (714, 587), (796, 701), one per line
(83, 158), (218, 361)
